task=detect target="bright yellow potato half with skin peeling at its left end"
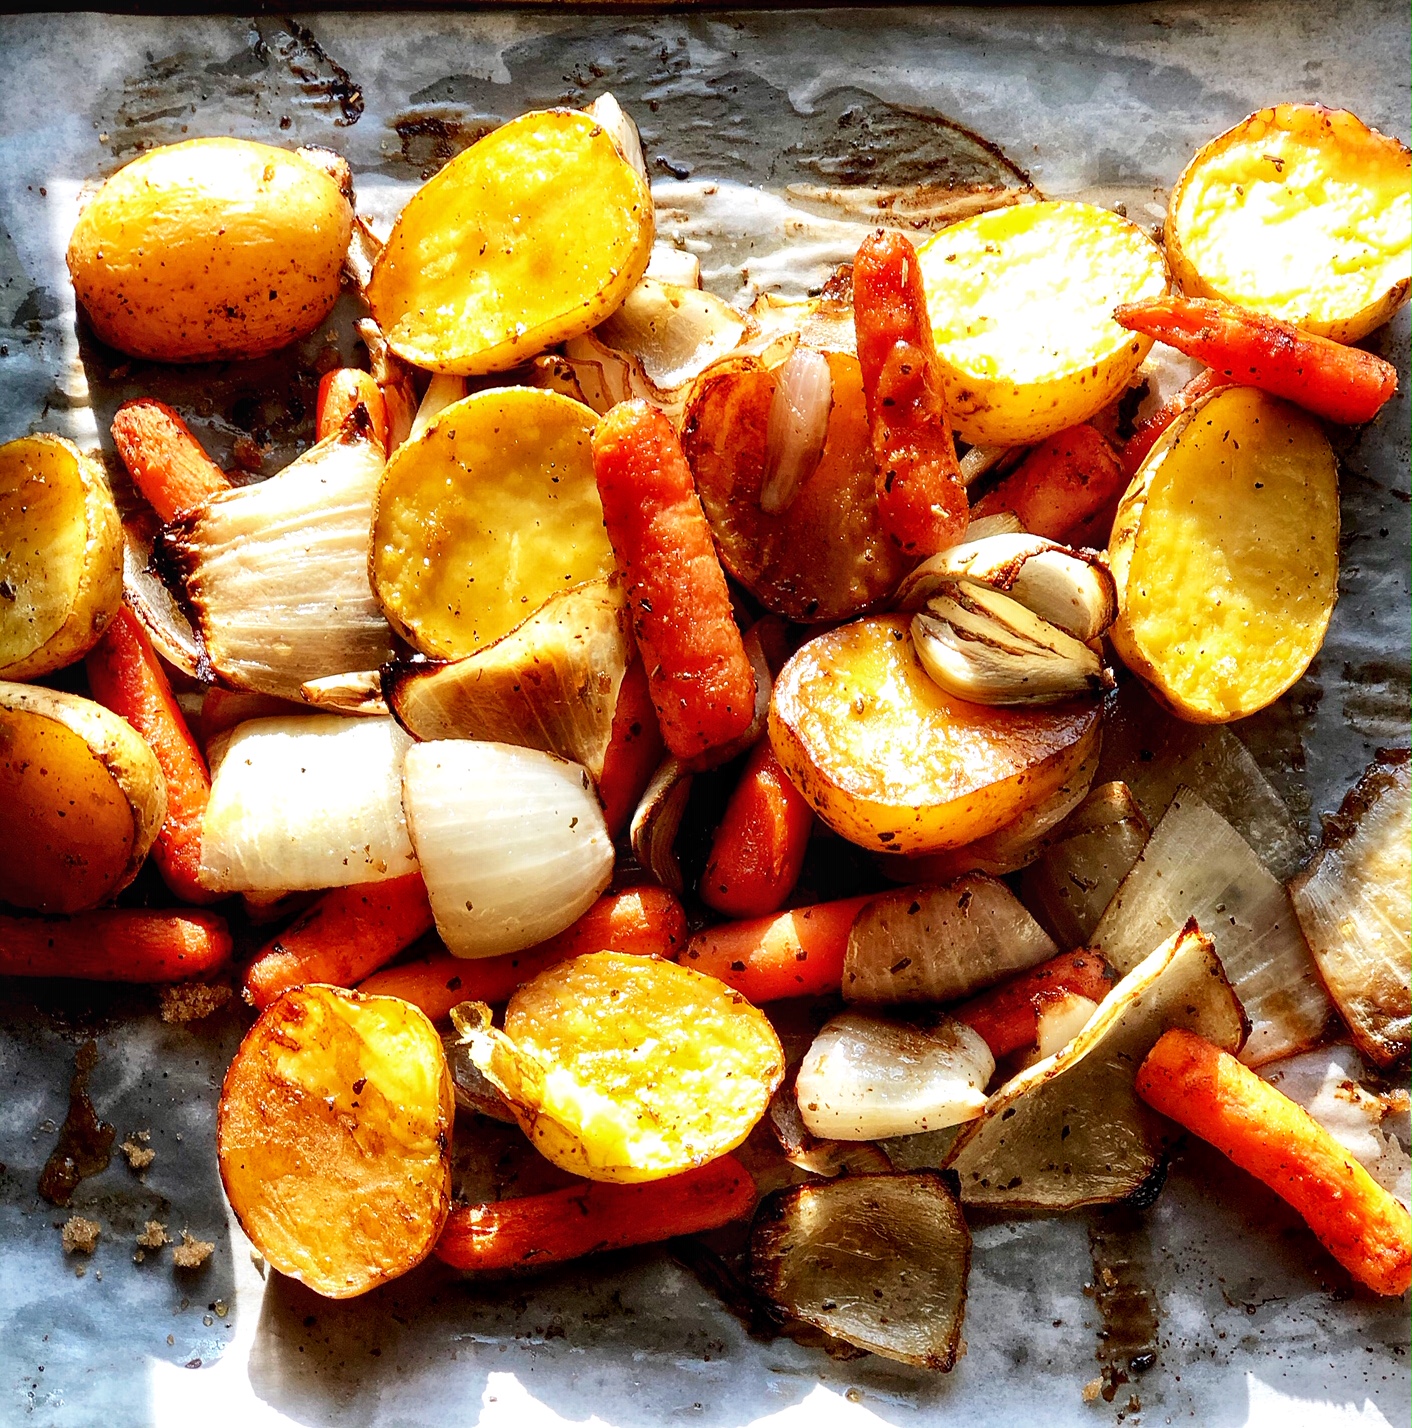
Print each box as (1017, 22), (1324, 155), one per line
(470, 951), (784, 1182)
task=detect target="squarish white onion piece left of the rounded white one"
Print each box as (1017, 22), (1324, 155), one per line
(201, 714), (417, 893)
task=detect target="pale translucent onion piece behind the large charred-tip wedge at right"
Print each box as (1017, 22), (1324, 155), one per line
(1089, 788), (1333, 1067)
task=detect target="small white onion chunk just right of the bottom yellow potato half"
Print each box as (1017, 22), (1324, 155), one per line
(795, 1011), (995, 1141)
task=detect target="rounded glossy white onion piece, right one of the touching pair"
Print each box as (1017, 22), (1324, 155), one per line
(403, 738), (612, 957)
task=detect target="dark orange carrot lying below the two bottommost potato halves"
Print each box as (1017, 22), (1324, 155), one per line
(435, 1155), (757, 1269)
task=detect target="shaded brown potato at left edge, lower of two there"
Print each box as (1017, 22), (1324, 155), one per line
(0, 681), (167, 912)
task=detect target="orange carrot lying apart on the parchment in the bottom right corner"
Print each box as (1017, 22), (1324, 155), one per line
(1136, 1030), (1412, 1295)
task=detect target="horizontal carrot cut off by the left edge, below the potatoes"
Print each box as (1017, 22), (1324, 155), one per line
(0, 907), (231, 982)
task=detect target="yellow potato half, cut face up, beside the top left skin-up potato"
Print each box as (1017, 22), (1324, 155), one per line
(367, 109), (654, 376)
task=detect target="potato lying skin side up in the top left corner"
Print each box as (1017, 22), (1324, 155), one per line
(69, 139), (353, 363)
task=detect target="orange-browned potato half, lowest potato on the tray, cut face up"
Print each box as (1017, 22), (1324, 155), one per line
(216, 985), (455, 1299)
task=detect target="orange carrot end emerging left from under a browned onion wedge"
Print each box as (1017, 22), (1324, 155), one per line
(677, 893), (877, 1004)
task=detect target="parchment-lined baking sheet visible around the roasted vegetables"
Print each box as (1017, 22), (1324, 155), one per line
(0, 0), (1412, 1428)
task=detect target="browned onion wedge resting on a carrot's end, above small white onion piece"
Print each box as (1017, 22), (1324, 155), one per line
(844, 873), (1058, 1002)
